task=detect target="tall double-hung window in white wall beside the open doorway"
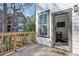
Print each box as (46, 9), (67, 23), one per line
(39, 11), (48, 37)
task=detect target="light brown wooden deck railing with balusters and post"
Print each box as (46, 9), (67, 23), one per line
(0, 32), (36, 55)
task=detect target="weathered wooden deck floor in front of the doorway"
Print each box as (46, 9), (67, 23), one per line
(5, 44), (78, 56)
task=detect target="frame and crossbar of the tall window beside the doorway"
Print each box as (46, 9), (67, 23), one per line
(38, 10), (49, 38)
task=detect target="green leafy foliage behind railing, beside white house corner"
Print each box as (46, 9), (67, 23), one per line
(25, 16), (35, 31)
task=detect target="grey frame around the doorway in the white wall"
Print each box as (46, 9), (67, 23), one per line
(51, 8), (72, 52)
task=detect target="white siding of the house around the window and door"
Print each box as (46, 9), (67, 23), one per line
(36, 3), (79, 54)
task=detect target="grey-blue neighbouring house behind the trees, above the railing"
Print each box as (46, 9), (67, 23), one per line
(0, 10), (26, 33)
